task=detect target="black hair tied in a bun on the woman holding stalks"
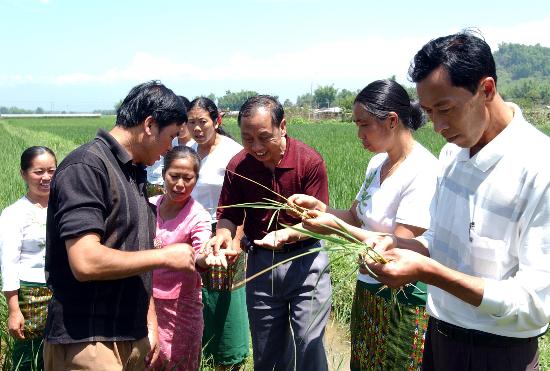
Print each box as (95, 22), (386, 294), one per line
(353, 80), (426, 130)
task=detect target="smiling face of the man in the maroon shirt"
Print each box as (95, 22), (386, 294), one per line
(241, 107), (286, 168)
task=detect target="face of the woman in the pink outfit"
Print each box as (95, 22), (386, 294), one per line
(164, 157), (197, 202)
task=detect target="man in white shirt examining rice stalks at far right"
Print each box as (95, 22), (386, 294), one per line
(362, 33), (550, 370)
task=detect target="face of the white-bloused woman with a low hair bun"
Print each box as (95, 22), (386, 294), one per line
(353, 103), (391, 153)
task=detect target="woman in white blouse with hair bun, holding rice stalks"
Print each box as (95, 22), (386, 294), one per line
(258, 80), (437, 370)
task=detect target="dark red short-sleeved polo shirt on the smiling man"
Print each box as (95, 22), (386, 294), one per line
(217, 136), (328, 241)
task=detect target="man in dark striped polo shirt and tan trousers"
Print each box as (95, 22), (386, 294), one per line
(44, 81), (194, 371)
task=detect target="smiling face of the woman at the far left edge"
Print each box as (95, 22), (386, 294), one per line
(21, 152), (57, 201)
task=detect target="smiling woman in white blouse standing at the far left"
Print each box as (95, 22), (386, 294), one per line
(0, 146), (57, 370)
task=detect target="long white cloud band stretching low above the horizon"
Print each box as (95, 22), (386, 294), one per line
(5, 17), (550, 87)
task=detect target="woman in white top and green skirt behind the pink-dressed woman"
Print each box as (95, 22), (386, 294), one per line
(187, 97), (249, 370)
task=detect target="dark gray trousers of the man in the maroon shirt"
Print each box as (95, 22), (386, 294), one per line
(246, 249), (332, 371)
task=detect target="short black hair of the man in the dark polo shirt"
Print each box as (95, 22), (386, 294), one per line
(116, 80), (187, 130)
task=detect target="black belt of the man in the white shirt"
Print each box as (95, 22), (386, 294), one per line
(429, 317), (537, 347)
